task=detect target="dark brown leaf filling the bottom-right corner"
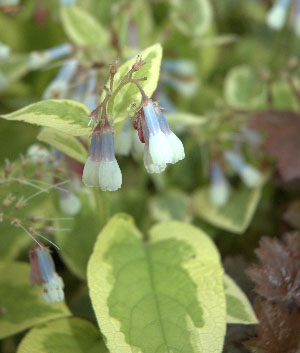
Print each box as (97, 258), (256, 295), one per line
(246, 300), (300, 353)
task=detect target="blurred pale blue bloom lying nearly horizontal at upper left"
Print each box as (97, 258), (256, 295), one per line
(28, 43), (73, 70)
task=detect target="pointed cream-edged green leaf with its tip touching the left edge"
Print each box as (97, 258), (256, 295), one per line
(1, 99), (91, 136)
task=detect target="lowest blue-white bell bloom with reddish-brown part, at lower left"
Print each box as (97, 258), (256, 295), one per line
(29, 245), (64, 303)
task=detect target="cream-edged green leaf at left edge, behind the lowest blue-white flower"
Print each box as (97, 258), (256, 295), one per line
(0, 262), (70, 338)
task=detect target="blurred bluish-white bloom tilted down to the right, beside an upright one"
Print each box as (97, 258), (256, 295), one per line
(225, 151), (262, 188)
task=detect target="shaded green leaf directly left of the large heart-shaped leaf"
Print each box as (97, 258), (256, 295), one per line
(55, 188), (101, 279)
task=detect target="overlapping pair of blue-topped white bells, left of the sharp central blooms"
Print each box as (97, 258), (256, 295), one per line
(82, 124), (122, 191)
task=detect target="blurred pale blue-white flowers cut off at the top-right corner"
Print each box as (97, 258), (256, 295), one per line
(267, 0), (300, 36)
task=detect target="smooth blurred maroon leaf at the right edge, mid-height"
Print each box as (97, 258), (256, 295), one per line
(250, 110), (300, 182)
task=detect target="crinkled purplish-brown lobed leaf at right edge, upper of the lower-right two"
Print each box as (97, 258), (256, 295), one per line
(248, 233), (300, 306)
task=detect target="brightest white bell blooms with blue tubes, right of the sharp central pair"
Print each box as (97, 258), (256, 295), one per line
(142, 99), (184, 173)
